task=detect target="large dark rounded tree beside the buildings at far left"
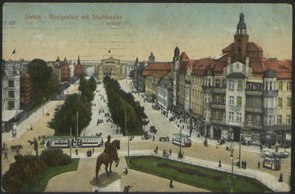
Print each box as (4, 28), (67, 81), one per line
(27, 59), (59, 108)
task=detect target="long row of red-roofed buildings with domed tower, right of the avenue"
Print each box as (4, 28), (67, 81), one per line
(135, 13), (292, 146)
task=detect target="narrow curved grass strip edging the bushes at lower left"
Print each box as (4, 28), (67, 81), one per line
(23, 159), (79, 192)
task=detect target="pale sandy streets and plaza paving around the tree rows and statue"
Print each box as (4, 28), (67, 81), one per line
(2, 79), (291, 192)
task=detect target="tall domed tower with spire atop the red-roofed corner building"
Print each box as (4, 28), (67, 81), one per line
(234, 13), (249, 62)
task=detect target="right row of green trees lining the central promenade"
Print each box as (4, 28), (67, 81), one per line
(103, 76), (147, 135)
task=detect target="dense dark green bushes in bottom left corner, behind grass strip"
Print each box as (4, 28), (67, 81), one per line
(2, 150), (71, 192)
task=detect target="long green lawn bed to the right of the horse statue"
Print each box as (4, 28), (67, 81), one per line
(126, 156), (272, 192)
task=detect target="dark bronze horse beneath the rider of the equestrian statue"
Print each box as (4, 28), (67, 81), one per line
(95, 140), (120, 179)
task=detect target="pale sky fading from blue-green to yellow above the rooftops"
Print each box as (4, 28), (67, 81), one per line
(2, 3), (292, 61)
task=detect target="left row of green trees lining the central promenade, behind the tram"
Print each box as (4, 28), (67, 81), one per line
(49, 77), (96, 135)
